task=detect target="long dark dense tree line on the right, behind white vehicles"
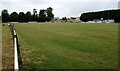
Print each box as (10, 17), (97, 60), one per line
(80, 9), (120, 23)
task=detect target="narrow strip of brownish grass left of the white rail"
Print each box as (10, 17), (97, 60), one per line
(2, 23), (14, 71)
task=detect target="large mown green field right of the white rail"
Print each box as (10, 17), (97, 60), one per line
(15, 23), (118, 69)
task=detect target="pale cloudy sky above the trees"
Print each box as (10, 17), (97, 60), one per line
(0, 0), (120, 17)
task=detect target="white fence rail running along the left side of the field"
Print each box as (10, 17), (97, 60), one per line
(8, 24), (22, 71)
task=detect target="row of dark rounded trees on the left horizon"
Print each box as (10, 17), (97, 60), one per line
(2, 7), (54, 22)
